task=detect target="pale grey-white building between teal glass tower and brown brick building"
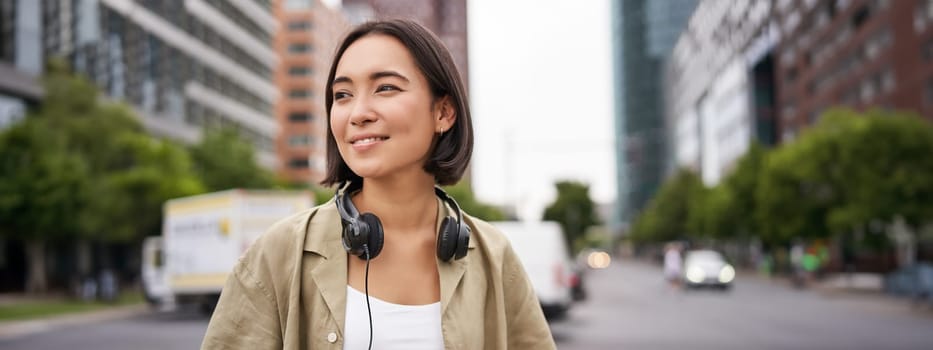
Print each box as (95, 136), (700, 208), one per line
(664, 0), (779, 186)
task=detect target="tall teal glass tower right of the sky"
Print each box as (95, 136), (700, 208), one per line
(612, 0), (696, 224)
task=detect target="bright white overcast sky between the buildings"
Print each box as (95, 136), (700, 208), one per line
(468, 0), (616, 219)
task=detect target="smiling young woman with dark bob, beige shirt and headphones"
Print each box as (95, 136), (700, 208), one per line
(202, 20), (555, 349)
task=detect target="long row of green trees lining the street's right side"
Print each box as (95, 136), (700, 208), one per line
(631, 109), (933, 252)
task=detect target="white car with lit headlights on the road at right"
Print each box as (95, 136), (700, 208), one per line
(683, 249), (735, 290)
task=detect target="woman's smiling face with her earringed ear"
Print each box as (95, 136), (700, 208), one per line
(330, 34), (454, 182)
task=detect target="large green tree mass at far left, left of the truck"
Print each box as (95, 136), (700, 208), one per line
(0, 61), (203, 291)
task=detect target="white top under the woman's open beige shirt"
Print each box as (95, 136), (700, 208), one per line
(343, 285), (444, 350)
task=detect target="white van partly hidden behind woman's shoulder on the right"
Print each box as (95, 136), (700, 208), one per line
(491, 221), (573, 320)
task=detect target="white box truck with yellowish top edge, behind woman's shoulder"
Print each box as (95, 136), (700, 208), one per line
(142, 189), (313, 312)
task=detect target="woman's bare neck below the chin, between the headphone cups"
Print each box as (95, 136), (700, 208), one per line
(352, 176), (437, 232)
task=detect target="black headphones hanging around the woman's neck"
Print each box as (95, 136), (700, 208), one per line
(334, 182), (470, 261)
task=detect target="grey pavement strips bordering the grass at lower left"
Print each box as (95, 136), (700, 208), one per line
(0, 295), (150, 341)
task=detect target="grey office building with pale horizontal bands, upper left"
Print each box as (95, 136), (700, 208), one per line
(36, 0), (279, 168)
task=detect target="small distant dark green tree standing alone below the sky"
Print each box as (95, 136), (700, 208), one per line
(543, 181), (600, 253)
